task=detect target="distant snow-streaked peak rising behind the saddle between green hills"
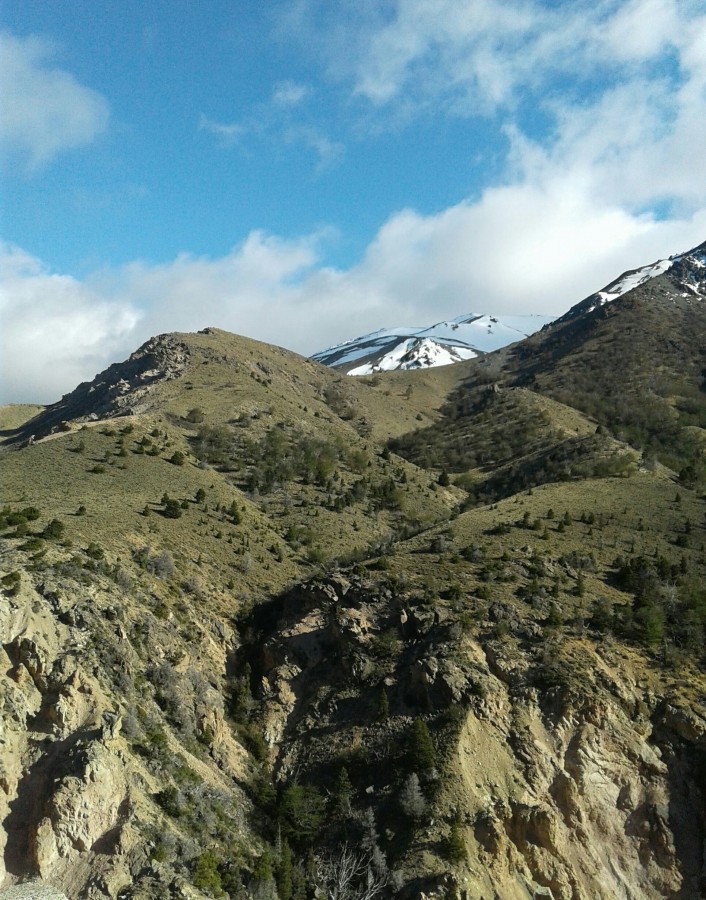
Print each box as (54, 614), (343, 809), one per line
(312, 314), (552, 375)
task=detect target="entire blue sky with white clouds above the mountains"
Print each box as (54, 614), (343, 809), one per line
(0, 0), (706, 402)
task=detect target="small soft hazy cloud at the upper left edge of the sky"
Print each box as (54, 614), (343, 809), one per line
(0, 33), (109, 170)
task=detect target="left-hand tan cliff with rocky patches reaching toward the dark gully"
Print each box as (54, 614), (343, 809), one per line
(0, 560), (248, 898)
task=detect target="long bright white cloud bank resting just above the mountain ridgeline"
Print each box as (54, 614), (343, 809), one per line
(0, 190), (706, 402)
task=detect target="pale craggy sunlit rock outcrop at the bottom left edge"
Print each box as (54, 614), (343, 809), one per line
(0, 572), (131, 889)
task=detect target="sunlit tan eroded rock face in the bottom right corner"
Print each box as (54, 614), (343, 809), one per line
(452, 684), (706, 900)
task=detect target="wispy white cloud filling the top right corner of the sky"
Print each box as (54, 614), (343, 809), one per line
(296, 0), (706, 200)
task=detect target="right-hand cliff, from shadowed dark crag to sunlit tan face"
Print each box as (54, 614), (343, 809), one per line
(236, 582), (706, 900)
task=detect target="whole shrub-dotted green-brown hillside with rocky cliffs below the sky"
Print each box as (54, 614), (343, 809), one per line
(0, 248), (706, 900)
